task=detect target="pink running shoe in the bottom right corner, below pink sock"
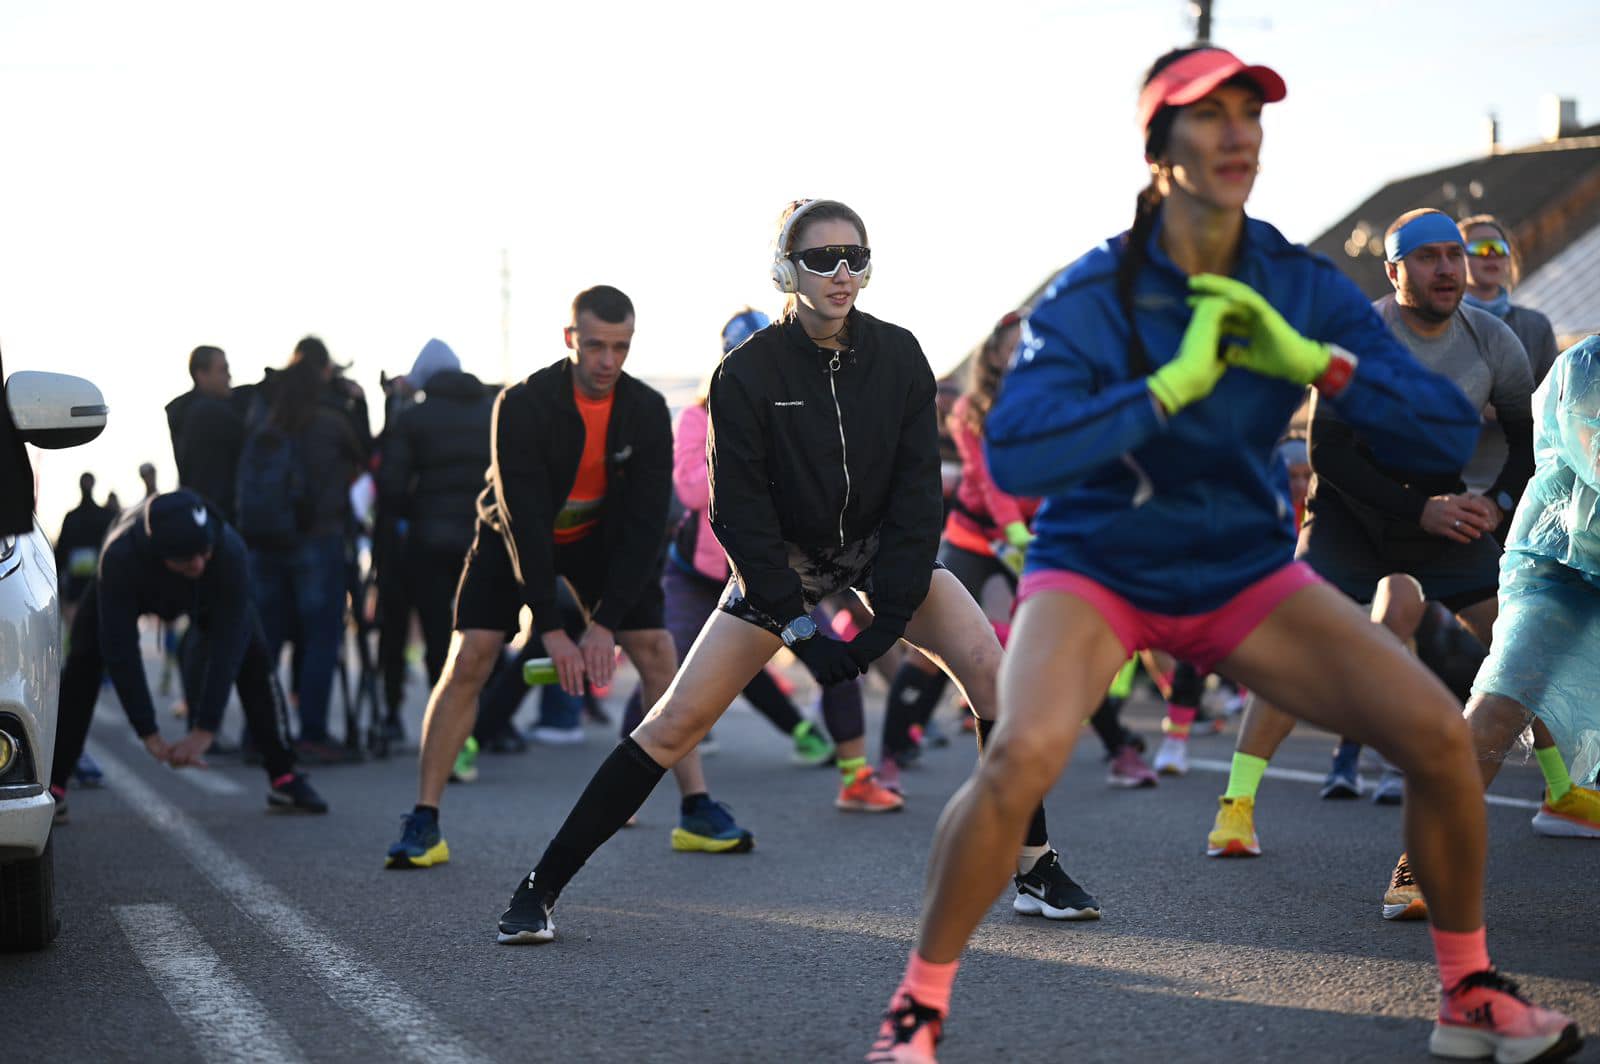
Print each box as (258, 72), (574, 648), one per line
(1427, 968), (1584, 1064)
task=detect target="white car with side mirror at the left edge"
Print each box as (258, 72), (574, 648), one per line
(0, 373), (106, 950)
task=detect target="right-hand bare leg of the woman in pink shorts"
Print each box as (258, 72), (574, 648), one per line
(1221, 586), (1486, 931)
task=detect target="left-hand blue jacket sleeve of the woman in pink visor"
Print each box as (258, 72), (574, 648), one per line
(984, 308), (1165, 496)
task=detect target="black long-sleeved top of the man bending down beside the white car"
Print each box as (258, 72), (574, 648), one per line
(94, 496), (256, 739)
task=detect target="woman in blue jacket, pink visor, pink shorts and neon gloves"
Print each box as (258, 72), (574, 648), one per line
(867, 48), (1578, 1061)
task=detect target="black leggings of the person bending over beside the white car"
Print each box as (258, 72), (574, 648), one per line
(50, 584), (294, 787)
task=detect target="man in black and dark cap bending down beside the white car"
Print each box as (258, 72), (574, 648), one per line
(50, 491), (328, 816)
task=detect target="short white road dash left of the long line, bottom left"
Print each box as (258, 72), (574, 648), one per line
(112, 904), (306, 1064)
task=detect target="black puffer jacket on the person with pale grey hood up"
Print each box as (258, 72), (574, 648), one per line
(378, 371), (494, 557)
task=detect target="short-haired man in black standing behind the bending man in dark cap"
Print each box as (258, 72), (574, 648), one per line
(166, 346), (245, 522)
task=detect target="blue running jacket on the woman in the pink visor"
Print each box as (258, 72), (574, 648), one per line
(986, 219), (1478, 616)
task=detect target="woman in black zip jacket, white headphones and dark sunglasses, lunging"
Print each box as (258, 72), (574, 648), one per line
(499, 200), (1099, 942)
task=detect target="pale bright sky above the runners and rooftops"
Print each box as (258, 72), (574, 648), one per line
(0, 0), (1600, 534)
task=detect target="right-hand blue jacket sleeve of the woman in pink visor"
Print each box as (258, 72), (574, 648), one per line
(1312, 270), (1478, 474)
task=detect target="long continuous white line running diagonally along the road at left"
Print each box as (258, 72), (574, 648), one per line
(90, 742), (488, 1064)
